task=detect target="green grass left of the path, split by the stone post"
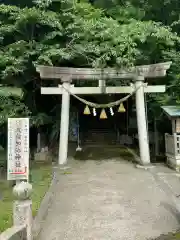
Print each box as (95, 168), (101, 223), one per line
(0, 163), (52, 232)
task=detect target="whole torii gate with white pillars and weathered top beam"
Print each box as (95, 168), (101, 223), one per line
(36, 62), (171, 165)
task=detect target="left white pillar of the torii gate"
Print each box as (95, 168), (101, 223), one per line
(58, 77), (71, 165)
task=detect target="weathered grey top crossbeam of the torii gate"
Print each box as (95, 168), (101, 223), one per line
(36, 62), (172, 80)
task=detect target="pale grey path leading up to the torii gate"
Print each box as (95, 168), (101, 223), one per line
(39, 159), (180, 240)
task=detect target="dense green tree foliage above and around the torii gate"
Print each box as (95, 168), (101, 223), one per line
(0, 0), (180, 143)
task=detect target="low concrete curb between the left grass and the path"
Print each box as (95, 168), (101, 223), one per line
(32, 166), (58, 239)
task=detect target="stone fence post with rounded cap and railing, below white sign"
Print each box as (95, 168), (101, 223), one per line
(0, 182), (32, 240)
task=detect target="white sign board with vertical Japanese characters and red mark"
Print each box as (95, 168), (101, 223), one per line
(7, 118), (29, 180)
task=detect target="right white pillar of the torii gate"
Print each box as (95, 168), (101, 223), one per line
(134, 76), (150, 165)
